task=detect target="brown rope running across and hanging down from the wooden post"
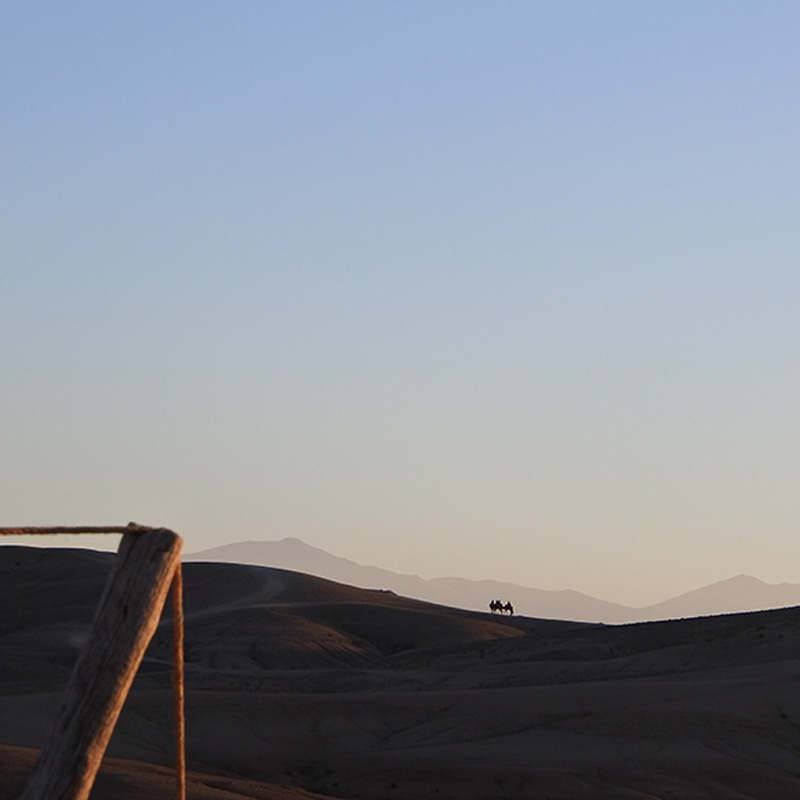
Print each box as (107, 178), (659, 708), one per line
(0, 522), (186, 800)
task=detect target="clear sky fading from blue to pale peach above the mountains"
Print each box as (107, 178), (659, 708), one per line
(0, 0), (800, 605)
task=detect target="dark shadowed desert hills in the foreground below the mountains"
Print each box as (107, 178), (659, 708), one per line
(0, 546), (800, 800)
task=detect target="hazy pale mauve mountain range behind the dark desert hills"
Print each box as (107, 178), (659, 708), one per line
(184, 538), (800, 623)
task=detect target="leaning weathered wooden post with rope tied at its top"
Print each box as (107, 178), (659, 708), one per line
(21, 528), (183, 800)
